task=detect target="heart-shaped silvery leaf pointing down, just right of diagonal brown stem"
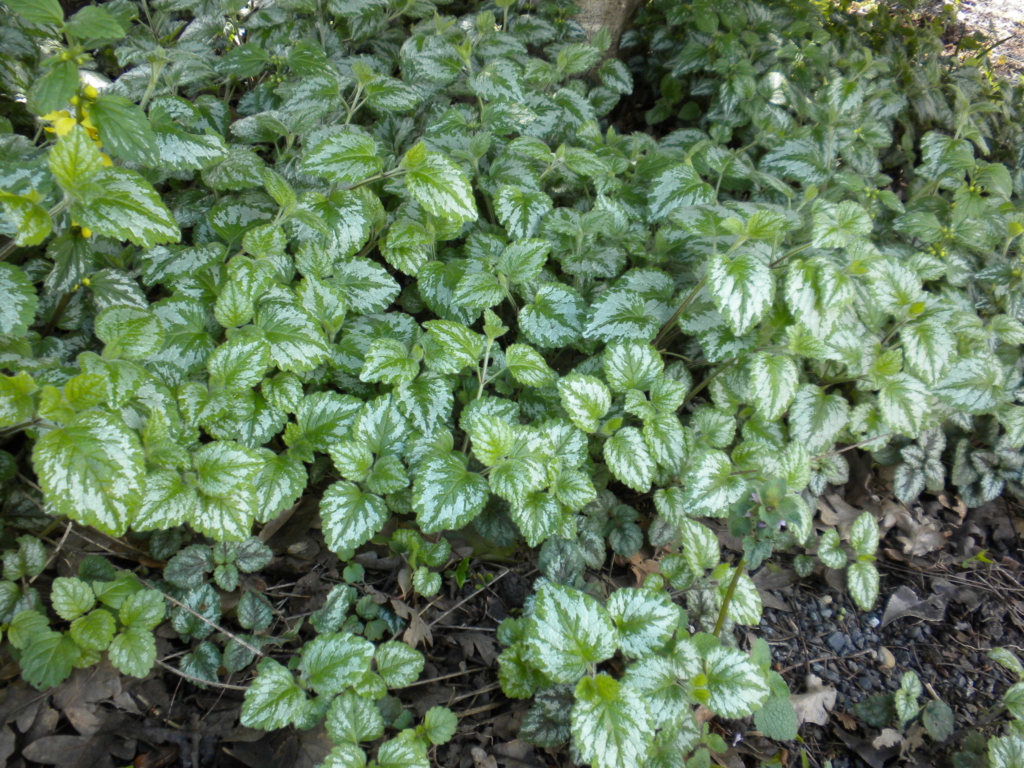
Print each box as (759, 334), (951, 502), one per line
(708, 253), (774, 335)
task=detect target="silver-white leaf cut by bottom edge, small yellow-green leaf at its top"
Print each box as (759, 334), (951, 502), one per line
(571, 673), (654, 768)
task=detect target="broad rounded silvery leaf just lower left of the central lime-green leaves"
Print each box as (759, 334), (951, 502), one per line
(413, 454), (489, 534)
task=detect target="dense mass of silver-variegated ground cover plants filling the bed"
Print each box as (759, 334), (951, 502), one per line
(0, 0), (1024, 768)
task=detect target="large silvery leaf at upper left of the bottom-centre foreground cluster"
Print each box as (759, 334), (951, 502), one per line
(525, 582), (616, 683)
